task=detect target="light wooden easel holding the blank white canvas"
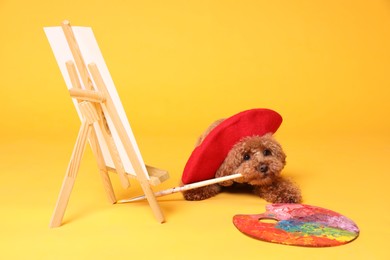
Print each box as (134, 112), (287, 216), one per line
(50, 21), (168, 227)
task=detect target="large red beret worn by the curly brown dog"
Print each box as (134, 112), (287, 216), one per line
(182, 109), (282, 184)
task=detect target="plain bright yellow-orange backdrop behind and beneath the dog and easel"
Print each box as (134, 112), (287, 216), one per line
(0, 0), (390, 259)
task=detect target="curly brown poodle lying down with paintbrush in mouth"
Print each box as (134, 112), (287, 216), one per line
(183, 119), (302, 203)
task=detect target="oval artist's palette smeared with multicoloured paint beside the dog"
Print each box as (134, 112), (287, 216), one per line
(233, 204), (359, 247)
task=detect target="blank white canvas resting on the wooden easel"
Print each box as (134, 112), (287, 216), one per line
(44, 26), (149, 180)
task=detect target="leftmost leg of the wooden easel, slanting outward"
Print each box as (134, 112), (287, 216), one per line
(50, 121), (92, 227)
